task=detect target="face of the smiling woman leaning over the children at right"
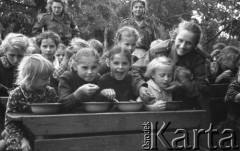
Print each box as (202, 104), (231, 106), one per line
(174, 29), (196, 56)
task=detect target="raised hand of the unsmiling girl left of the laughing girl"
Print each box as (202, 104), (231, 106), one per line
(74, 83), (99, 98)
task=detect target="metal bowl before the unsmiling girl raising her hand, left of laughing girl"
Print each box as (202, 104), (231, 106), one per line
(82, 102), (112, 113)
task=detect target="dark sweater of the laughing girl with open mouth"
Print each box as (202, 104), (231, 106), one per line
(98, 73), (136, 101)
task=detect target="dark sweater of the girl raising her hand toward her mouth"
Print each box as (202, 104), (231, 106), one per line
(58, 71), (100, 111)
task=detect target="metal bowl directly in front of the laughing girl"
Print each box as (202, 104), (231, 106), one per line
(116, 101), (143, 112)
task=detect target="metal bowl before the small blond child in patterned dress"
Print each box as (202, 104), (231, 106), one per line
(29, 103), (62, 114)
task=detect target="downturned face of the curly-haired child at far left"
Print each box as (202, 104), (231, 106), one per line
(5, 48), (24, 66)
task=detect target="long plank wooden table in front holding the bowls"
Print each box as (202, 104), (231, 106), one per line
(10, 110), (206, 151)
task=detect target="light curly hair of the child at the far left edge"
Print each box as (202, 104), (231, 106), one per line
(0, 33), (29, 54)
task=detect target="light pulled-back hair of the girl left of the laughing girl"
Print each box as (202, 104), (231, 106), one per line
(73, 47), (100, 64)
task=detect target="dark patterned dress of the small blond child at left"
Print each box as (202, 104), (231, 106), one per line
(4, 86), (57, 151)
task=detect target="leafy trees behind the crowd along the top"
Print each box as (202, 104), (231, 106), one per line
(0, 0), (240, 52)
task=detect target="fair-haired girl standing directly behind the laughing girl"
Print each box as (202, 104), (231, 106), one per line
(99, 26), (139, 75)
